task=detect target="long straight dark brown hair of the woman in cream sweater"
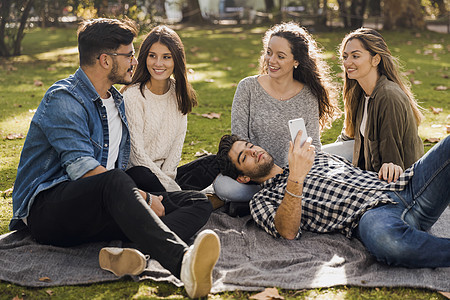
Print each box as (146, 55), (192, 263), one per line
(123, 25), (198, 115)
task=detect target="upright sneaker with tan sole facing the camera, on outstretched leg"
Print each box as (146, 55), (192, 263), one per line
(180, 229), (220, 298)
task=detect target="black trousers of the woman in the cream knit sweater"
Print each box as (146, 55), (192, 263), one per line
(127, 154), (220, 192)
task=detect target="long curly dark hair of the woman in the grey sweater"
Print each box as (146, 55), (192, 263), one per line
(259, 22), (340, 128)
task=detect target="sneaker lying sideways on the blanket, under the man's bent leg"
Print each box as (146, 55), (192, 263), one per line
(98, 247), (147, 276)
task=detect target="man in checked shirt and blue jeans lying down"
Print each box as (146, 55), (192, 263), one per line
(217, 131), (450, 268)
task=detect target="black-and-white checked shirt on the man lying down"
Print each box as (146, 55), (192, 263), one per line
(250, 152), (414, 239)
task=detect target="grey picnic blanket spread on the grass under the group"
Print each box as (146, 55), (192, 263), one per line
(0, 208), (450, 293)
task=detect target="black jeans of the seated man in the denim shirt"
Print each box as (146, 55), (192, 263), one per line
(27, 169), (212, 277)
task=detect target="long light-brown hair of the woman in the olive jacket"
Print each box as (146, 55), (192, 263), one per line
(339, 28), (423, 137)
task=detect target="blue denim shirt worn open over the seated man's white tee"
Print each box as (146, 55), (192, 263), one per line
(9, 68), (130, 230)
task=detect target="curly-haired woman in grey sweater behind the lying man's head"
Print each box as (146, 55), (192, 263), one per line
(214, 22), (339, 202)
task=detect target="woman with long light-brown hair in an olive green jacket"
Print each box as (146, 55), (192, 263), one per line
(340, 28), (423, 181)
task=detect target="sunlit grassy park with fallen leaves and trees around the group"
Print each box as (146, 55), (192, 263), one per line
(0, 0), (450, 299)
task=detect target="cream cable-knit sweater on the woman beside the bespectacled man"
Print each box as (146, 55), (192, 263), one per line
(123, 82), (187, 191)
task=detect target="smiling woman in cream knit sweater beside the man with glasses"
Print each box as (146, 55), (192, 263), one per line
(122, 26), (218, 192)
